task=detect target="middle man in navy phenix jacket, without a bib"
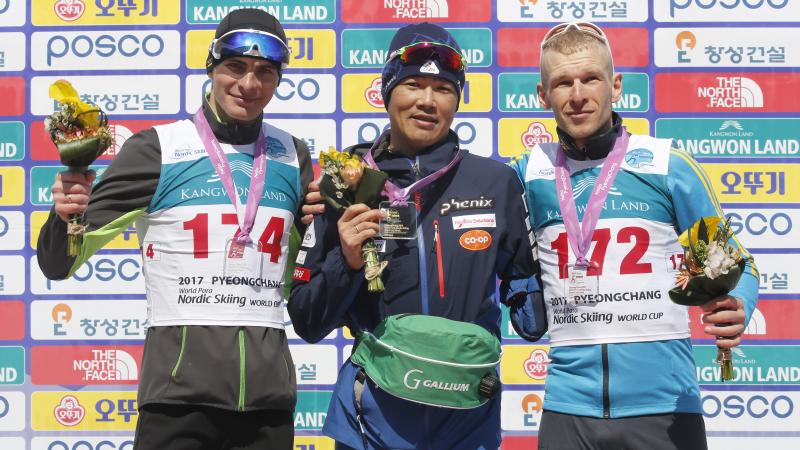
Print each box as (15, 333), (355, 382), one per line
(288, 23), (544, 449)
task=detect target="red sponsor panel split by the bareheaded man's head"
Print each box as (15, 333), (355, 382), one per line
(497, 28), (650, 67)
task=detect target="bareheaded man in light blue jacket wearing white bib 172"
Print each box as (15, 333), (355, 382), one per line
(512, 22), (758, 450)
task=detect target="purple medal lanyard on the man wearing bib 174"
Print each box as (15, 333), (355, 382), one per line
(194, 108), (267, 244)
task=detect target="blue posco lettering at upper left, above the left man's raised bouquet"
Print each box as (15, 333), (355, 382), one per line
(47, 33), (165, 66)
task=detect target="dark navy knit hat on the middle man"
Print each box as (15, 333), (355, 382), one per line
(381, 22), (465, 109)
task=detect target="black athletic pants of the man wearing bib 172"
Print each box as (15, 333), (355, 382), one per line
(539, 411), (708, 450)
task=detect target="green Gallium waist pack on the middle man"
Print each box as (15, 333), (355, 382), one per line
(351, 314), (501, 409)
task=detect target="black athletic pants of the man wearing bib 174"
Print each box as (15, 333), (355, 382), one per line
(133, 404), (294, 450)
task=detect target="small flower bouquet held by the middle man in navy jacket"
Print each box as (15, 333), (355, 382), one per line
(319, 148), (387, 292)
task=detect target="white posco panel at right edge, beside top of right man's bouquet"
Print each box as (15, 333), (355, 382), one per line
(725, 208), (800, 249)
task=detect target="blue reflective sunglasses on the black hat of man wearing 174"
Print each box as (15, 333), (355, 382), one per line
(208, 30), (292, 69)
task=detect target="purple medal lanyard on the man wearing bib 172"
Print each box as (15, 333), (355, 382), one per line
(556, 127), (630, 267)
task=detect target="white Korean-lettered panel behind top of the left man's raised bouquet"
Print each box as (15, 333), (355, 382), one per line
(31, 75), (181, 117)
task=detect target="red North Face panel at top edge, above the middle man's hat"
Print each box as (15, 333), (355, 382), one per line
(342, 0), (492, 23)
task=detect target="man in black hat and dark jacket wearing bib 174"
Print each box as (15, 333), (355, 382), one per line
(37, 9), (313, 450)
